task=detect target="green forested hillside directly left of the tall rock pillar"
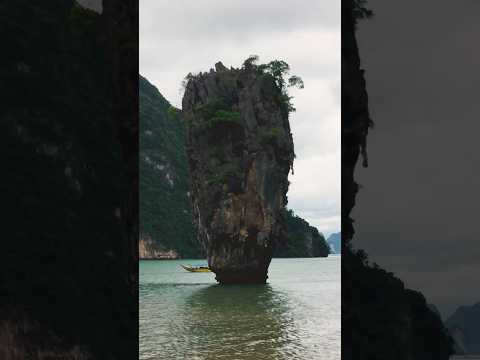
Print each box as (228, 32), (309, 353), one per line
(139, 76), (200, 257)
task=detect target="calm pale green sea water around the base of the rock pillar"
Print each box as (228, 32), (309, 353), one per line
(140, 255), (341, 360)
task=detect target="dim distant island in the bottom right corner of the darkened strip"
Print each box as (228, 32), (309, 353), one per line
(445, 302), (480, 357)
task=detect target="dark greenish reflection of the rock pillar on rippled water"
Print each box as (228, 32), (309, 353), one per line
(179, 285), (300, 360)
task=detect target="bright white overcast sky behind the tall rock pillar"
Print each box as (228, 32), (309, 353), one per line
(140, 0), (340, 235)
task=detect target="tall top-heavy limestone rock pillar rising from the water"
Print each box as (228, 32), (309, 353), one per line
(182, 63), (294, 283)
